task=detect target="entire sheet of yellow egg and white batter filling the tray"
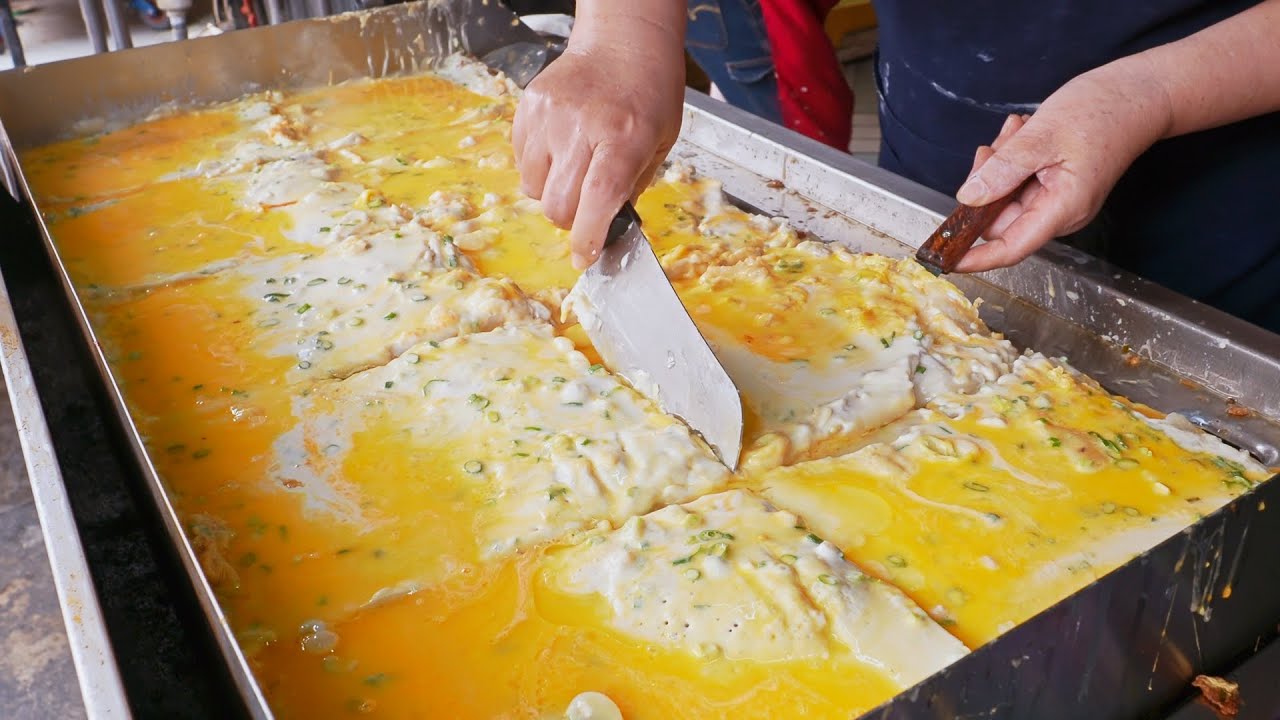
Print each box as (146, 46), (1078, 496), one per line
(23, 59), (1266, 719)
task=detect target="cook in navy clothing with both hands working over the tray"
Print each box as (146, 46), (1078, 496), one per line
(512, 0), (1280, 332)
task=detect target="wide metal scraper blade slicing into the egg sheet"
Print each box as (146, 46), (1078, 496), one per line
(575, 202), (742, 470)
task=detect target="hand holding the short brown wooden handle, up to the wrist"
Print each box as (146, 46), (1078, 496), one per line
(956, 59), (1172, 273)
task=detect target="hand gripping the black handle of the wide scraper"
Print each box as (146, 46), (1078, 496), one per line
(512, 20), (685, 269)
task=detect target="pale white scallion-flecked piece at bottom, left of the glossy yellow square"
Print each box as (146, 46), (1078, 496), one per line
(550, 489), (965, 687)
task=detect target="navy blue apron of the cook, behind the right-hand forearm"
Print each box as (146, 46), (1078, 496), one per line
(876, 0), (1280, 332)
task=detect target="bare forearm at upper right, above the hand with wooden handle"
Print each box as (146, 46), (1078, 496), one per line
(1117, 0), (1280, 137)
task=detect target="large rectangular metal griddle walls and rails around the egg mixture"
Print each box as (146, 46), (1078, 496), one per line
(0, 0), (1280, 719)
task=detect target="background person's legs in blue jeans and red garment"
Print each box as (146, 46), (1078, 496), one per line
(685, 0), (854, 151)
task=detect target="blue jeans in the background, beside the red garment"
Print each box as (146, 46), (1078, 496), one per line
(685, 0), (782, 124)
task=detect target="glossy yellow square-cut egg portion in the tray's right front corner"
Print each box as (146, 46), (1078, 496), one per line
(758, 355), (1268, 647)
